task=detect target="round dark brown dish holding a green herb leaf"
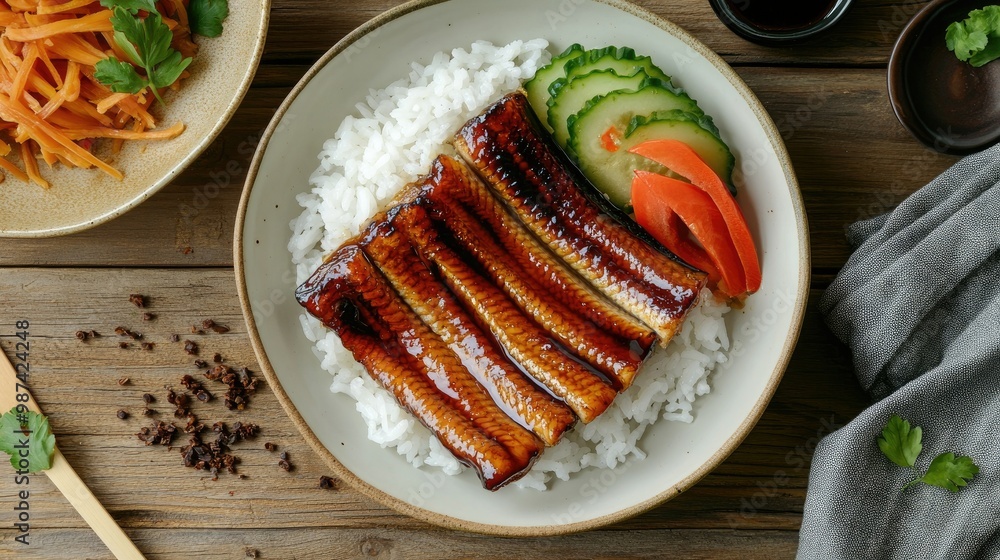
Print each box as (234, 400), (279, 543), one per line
(888, 0), (1000, 155)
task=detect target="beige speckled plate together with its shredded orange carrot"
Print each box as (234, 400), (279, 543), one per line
(0, 0), (270, 237)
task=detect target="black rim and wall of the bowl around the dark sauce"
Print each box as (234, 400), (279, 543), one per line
(709, 0), (854, 46)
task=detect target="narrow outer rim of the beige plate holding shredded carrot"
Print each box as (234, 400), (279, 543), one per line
(0, 0), (271, 238)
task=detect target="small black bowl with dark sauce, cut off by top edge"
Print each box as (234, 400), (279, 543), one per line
(709, 0), (854, 46)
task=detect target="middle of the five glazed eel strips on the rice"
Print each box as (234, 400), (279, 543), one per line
(394, 199), (618, 422)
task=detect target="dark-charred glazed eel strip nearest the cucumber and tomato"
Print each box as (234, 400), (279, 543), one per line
(455, 92), (706, 345)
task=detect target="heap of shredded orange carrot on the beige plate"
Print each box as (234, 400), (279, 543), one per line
(0, 0), (198, 188)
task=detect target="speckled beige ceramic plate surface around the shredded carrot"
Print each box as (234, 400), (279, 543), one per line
(0, 0), (271, 237)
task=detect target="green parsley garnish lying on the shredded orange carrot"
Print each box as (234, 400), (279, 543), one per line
(94, 0), (229, 103)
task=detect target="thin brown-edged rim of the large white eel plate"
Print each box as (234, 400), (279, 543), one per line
(233, 0), (811, 537)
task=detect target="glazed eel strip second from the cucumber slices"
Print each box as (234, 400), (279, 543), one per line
(420, 156), (656, 391)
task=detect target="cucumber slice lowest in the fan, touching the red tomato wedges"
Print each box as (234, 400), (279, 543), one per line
(619, 111), (736, 185)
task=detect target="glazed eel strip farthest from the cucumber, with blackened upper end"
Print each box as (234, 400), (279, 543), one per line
(296, 243), (543, 490)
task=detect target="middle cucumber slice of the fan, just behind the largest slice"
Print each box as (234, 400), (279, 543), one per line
(548, 70), (647, 152)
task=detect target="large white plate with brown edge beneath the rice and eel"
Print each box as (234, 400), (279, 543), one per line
(234, 0), (809, 535)
